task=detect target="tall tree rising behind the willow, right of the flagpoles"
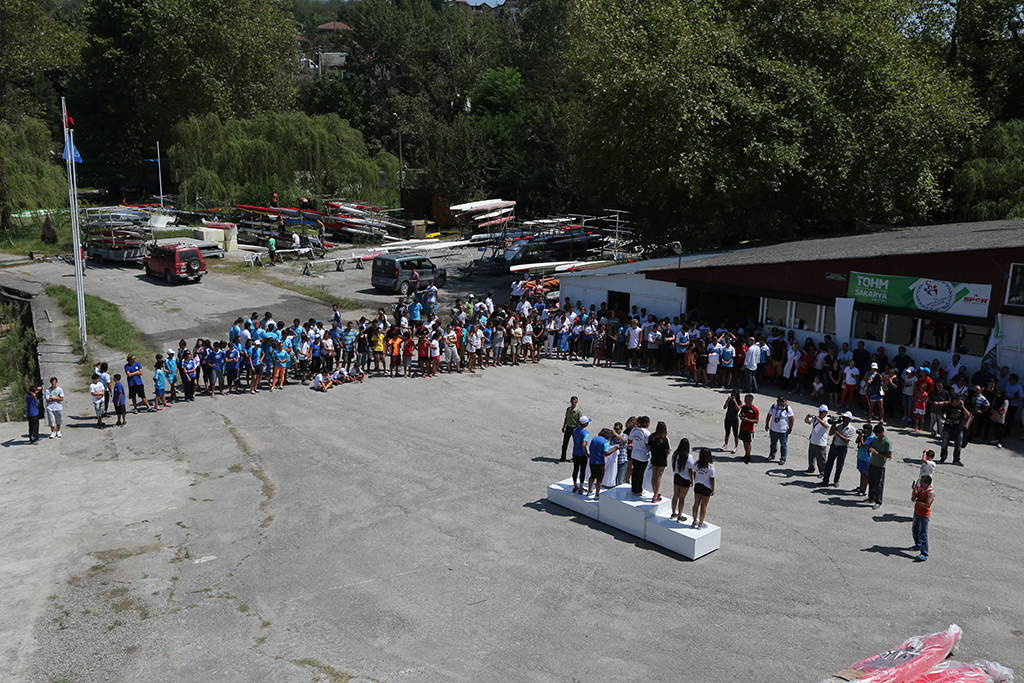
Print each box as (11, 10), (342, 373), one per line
(71, 0), (297, 181)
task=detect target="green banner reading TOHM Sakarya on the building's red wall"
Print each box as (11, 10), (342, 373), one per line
(847, 272), (992, 317)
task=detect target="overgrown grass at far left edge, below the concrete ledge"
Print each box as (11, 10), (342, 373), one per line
(0, 303), (43, 422)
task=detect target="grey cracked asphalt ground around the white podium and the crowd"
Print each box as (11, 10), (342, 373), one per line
(0, 258), (1024, 683)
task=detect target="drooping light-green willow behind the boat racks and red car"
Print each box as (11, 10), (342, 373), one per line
(169, 113), (398, 206)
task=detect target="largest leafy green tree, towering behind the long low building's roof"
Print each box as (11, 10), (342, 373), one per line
(572, 0), (982, 249)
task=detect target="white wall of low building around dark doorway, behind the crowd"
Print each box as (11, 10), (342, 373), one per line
(559, 274), (686, 318)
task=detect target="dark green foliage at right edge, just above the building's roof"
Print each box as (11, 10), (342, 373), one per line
(952, 119), (1024, 220)
